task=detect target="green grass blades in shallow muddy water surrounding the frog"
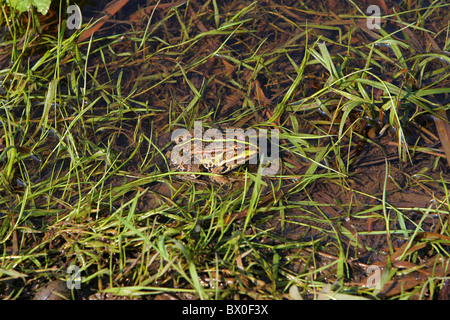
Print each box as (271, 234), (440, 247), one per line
(0, 0), (450, 299)
